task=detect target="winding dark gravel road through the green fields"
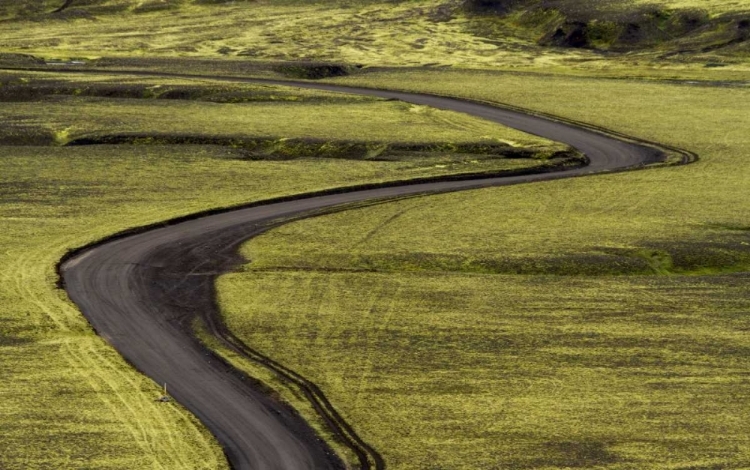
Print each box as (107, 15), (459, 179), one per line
(60, 72), (664, 470)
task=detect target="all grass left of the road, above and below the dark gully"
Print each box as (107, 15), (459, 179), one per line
(0, 73), (557, 470)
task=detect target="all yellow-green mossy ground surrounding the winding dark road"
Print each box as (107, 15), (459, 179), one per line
(0, 0), (750, 470)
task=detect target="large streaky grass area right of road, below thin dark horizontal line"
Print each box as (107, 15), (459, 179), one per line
(219, 270), (750, 469)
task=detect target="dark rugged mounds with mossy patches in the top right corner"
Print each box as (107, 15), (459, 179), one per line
(463, 0), (750, 56)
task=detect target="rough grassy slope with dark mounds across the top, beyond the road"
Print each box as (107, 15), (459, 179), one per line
(0, 0), (750, 70)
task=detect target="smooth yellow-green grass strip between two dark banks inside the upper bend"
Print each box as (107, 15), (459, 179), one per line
(0, 85), (549, 146)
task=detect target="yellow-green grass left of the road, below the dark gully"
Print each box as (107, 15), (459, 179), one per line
(0, 146), (536, 469)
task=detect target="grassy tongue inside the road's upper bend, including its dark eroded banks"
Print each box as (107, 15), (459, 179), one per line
(0, 73), (568, 171)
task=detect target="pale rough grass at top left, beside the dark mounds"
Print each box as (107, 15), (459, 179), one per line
(0, 0), (568, 65)
